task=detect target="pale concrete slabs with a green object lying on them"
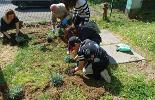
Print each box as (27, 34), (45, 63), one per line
(100, 30), (145, 64)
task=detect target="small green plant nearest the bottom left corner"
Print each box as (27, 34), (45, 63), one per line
(8, 86), (23, 100)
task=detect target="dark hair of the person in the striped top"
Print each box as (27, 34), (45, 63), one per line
(62, 0), (78, 10)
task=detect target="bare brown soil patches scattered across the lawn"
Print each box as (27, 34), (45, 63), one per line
(0, 24), (155, 100)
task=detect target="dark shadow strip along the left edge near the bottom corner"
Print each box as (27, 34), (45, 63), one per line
(0, 67), (8, 100)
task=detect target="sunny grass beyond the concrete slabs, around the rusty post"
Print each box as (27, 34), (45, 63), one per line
(92, 5), (155, 57)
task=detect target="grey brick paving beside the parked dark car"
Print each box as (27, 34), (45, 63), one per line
(0, 2), (51, 23)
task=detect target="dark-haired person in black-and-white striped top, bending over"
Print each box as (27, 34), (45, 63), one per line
(62, 0), (90, 27)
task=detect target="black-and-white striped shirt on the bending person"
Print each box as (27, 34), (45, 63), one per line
(74, 0), (90, 22)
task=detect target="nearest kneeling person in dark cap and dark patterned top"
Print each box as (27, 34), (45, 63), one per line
(68, 36), (111, 83)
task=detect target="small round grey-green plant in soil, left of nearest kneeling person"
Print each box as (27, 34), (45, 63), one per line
(51, 73), (64, 86)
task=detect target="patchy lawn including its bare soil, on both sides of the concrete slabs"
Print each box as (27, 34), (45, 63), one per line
(0, 2), (155, 100)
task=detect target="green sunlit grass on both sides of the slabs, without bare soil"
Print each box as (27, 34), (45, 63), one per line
(0, 2), (155, 100)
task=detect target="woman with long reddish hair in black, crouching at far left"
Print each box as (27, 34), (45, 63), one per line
(0, 9), (22, 41)
